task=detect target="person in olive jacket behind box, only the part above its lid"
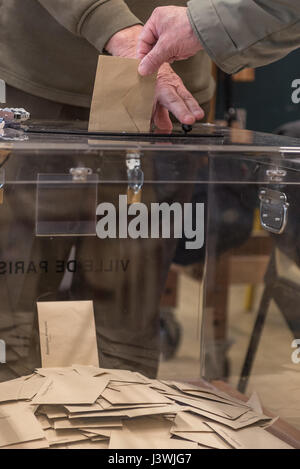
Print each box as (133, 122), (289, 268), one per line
(0, 0), (214, 129)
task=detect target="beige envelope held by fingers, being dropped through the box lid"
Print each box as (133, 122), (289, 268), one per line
(89, 55), (156, 132)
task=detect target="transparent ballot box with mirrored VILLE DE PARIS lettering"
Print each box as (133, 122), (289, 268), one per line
(0, 123), (300, 427)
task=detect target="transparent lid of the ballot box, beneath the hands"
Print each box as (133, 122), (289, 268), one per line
(0, 121), (300, 184)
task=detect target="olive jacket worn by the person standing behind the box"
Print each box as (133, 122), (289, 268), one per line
(0, 0), (214, 107)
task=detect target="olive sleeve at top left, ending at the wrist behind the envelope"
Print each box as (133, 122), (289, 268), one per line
(37, 0), (141, 52)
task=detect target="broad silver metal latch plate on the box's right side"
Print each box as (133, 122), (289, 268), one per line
(259, 188), (289, 234)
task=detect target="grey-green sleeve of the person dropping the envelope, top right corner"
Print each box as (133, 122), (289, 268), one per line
(188, 0), (300, 73)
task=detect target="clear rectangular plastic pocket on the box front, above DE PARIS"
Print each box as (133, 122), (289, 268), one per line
(36, 167), (98, 237)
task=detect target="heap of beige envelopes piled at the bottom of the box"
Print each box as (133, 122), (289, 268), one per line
(0, 365), (289, 449)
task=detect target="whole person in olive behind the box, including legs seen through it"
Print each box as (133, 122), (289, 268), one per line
(0, 0), (214, 381)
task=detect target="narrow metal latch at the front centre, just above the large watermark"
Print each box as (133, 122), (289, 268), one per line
(126, 151), (144, 205)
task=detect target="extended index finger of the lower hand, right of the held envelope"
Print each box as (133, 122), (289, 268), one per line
(158, 87), (196, 125)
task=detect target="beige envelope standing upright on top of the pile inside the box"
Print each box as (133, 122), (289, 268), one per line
(37, 301), (99, 367)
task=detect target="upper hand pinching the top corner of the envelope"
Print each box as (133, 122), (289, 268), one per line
(137, 6), (203, 75)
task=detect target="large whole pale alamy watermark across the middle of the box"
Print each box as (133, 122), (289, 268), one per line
(96, 195), (204, 249)
